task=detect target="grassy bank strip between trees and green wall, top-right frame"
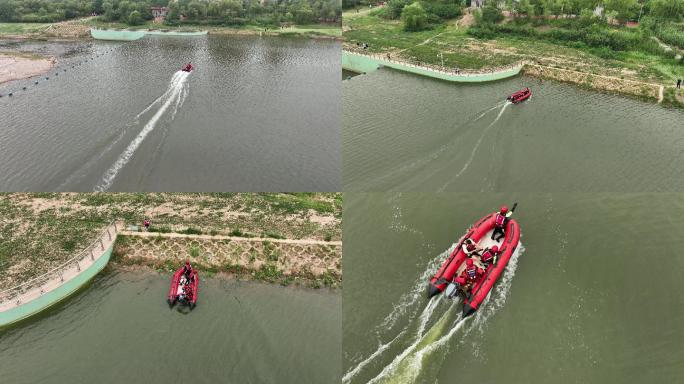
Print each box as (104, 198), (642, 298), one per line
(343, 11), (684, 106)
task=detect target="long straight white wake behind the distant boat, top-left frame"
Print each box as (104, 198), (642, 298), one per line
(94, 71), (190, 192)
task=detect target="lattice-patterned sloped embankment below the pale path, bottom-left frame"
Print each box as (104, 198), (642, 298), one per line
(115, 232), (342, 281)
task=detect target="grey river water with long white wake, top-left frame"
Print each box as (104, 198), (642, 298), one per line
(0, 36), (341, 192)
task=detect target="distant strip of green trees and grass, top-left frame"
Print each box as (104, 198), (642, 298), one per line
(0, 0), (341, 26)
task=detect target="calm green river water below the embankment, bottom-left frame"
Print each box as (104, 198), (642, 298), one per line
(0, 272), (341, 384)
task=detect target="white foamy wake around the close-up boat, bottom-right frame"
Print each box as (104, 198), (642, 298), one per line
(342, 238), (525, 384)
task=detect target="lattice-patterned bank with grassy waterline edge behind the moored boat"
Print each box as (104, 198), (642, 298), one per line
(112, 234), (342, 288)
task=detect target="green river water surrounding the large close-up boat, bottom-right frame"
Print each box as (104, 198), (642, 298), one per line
(343, 193), (684, 384)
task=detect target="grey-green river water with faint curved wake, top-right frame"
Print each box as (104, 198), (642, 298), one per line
(342, 69), (684, 192)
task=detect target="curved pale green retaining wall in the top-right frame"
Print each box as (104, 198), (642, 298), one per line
(342, 51), (522, 83)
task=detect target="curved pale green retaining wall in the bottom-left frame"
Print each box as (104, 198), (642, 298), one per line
(0, 245), (114, 327)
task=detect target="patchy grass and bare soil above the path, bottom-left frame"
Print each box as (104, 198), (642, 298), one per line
(0, 193), (342, 288)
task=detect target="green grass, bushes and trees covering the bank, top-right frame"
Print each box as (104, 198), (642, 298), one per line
(343, 0), (684, 105)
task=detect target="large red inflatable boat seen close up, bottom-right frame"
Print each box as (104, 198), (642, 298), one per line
(428, 208), (520, 317)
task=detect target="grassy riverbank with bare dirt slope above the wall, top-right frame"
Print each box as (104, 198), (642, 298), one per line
(343, 12), (684, 107)
